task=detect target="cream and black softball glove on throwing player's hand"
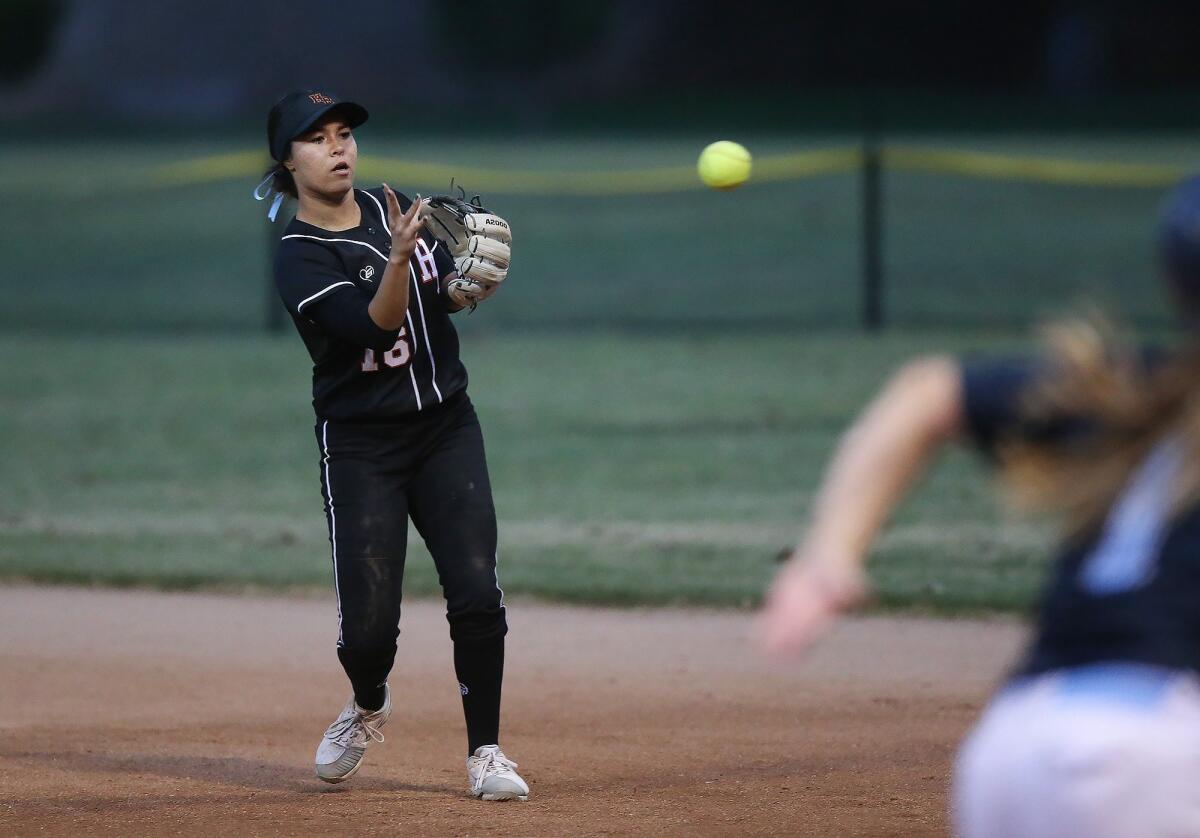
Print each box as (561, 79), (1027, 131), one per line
(421, 194), (512, 310)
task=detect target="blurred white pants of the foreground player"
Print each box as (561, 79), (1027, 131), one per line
(954, 664), (1200, 838)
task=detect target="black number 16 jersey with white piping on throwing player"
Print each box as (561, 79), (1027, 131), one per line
(275, 182), (467, 421)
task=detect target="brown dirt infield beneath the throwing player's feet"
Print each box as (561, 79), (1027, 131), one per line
(0, 587), (1022, 836)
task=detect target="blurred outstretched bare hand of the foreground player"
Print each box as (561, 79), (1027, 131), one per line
(755, 549), (866, 654)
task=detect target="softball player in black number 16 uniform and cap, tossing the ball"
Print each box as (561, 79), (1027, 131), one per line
(256, 90), (529, 800)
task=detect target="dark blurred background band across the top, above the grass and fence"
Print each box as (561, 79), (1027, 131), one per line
(0, 0), (1200, 126)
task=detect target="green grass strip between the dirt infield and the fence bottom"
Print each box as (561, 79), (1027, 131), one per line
(0, 328), (1046, 611)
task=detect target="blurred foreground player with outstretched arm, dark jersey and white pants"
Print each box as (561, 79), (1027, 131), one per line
(760, 172), (1200, 838)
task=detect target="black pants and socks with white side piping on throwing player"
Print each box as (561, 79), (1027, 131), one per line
(317, 393), (508, 752)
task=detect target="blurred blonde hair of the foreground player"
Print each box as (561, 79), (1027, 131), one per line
(1001, 315), (1200, 535)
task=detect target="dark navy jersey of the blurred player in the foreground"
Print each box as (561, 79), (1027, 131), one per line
(962, 363), (1200, 676)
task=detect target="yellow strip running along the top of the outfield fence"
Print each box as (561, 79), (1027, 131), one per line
(154, 145), (1192, 197)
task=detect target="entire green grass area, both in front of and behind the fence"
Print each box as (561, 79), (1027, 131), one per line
(0, 132), (1200, 611)
